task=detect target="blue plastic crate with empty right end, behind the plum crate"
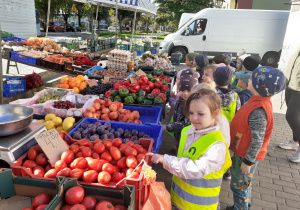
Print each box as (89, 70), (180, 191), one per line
(123, 106), (162, 125)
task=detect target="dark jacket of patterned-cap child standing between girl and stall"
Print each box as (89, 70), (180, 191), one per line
(166, 97), (191, 142)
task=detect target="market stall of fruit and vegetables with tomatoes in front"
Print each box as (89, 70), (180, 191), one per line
(0, 35), (174, 210)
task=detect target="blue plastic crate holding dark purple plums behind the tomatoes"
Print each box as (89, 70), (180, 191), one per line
(69, 117), (163, 153)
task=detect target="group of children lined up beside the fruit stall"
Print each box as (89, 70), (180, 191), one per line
(149, 54), (286, 210)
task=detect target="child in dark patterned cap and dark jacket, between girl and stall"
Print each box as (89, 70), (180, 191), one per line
(164, 69), (199, 153)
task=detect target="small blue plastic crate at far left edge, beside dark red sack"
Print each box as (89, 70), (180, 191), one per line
(3, 78), (26, 97)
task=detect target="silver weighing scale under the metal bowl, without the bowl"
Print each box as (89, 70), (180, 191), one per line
(0, 122), (46, 168)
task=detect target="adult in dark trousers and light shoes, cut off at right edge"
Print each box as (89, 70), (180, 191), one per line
(278, 46), (300, 163)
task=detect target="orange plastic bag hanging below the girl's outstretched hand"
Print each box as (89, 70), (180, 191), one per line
(142, 182), (172, 210)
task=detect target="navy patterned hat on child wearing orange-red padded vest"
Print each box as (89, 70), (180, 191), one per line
(252, 66), (286, 97)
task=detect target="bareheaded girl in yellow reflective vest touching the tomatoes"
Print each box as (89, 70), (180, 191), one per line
(147, 89), (231, 210)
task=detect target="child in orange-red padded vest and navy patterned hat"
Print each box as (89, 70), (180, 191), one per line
(226, 67), (286, 210)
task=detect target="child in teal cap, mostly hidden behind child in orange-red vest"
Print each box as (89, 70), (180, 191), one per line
(235, 71), (253, 106)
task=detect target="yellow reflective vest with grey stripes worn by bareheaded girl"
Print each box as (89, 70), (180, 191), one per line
(171, 125), (231, 210)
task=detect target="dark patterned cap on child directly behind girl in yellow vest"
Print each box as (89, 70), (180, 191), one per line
(179, 69), (199, 91)
